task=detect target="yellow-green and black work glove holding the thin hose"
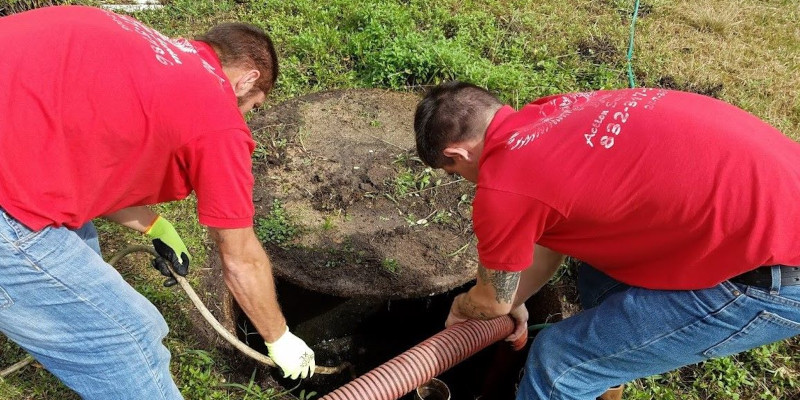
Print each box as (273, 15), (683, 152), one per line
(145, 215), (189, 287)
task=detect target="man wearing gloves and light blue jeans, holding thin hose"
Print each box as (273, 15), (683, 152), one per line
(0, 7), (314, 399)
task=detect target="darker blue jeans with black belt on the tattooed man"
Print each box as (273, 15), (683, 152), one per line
(517, 264), (800, 400)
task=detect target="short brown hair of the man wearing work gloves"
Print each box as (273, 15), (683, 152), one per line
(197, 22), (278, 94)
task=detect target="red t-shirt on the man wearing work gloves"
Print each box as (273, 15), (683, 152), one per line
(0, 6), (254, 230)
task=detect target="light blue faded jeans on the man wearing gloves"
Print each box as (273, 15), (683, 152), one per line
(0, 209), (182, 400)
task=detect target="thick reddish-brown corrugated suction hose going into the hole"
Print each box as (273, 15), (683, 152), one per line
(320, 315), (516, 400)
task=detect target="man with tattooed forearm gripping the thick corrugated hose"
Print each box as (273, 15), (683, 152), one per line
(414, 82), (800, 399)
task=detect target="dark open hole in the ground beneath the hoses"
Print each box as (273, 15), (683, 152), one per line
(231, 280), (561, 400)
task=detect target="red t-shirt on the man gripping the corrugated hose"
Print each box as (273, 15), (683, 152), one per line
(473, 89), (800, 289)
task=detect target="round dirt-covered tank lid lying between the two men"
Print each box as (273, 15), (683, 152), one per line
(249, 89), (477, 298)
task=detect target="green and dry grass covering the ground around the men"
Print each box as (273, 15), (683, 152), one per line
(0, 0), (800, 400)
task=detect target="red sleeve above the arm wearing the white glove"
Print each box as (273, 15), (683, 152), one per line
(182, 129), (255, 228)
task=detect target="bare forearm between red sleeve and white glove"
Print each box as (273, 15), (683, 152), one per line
(210, 228), (286, 342)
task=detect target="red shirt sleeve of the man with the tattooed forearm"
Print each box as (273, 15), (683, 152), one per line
(472, 187), (562, 272)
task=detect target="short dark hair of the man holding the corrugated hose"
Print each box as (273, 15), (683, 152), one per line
(414, 81), (503, 168)
